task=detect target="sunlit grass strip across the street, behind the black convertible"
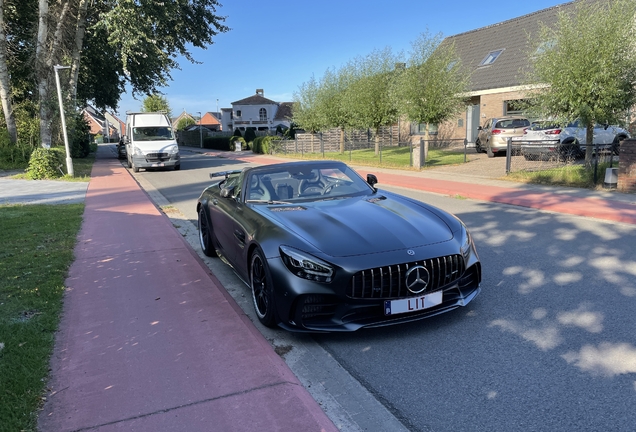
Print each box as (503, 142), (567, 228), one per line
(276, 147), (464, 169)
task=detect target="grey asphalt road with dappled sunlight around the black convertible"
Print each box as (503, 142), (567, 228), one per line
(126, 149), (636, 431)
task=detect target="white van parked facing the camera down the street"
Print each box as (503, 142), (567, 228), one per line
(124, 112), (181, 172)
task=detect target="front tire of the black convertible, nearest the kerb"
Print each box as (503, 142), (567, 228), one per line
(250, 249), (276, 327)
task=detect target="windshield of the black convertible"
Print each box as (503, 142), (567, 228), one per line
(245, 163), (373, 203)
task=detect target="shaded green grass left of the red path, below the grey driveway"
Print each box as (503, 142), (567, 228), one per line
(0, 204), (84, 431)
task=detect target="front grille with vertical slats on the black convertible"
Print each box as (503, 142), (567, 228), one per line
(347, 255), (465, 299)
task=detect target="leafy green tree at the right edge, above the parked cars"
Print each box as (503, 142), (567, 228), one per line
(527, 0), (636, 163)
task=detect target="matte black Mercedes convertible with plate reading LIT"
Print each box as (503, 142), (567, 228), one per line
(197, 161), (481, 331)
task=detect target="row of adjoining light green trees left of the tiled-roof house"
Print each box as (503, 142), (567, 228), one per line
(293, 33), (469, 153)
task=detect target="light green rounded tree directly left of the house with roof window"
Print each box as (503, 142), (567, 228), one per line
(393, 32), (469, 147)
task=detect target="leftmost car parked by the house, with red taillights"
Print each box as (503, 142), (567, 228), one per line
(475, 116), (530, 157)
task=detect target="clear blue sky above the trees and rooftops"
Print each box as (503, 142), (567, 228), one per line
(116, 0), (567, 120)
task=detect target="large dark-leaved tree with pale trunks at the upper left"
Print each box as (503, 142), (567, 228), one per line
(0, 0), (229, 148)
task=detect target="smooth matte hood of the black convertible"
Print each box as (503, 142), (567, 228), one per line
(261, 194), (453, 257)
